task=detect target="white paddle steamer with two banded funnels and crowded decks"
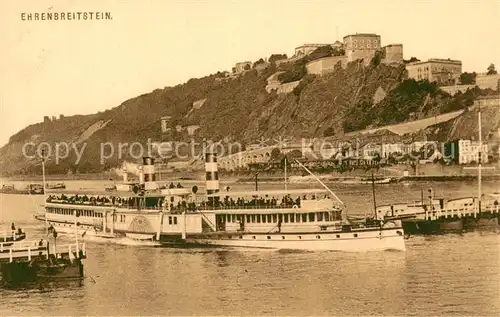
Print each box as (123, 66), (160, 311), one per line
(38, 153), (405, 251)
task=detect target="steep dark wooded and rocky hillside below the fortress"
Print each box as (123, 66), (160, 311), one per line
(0, 56), (498, 176)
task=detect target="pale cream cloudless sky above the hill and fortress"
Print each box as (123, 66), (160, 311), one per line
(0, 0), (500, 146)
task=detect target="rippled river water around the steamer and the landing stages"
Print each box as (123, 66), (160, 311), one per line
(0, 181), (500, 316)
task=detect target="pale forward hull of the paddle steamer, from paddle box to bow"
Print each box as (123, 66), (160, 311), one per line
(162, 228), (406, 252)
